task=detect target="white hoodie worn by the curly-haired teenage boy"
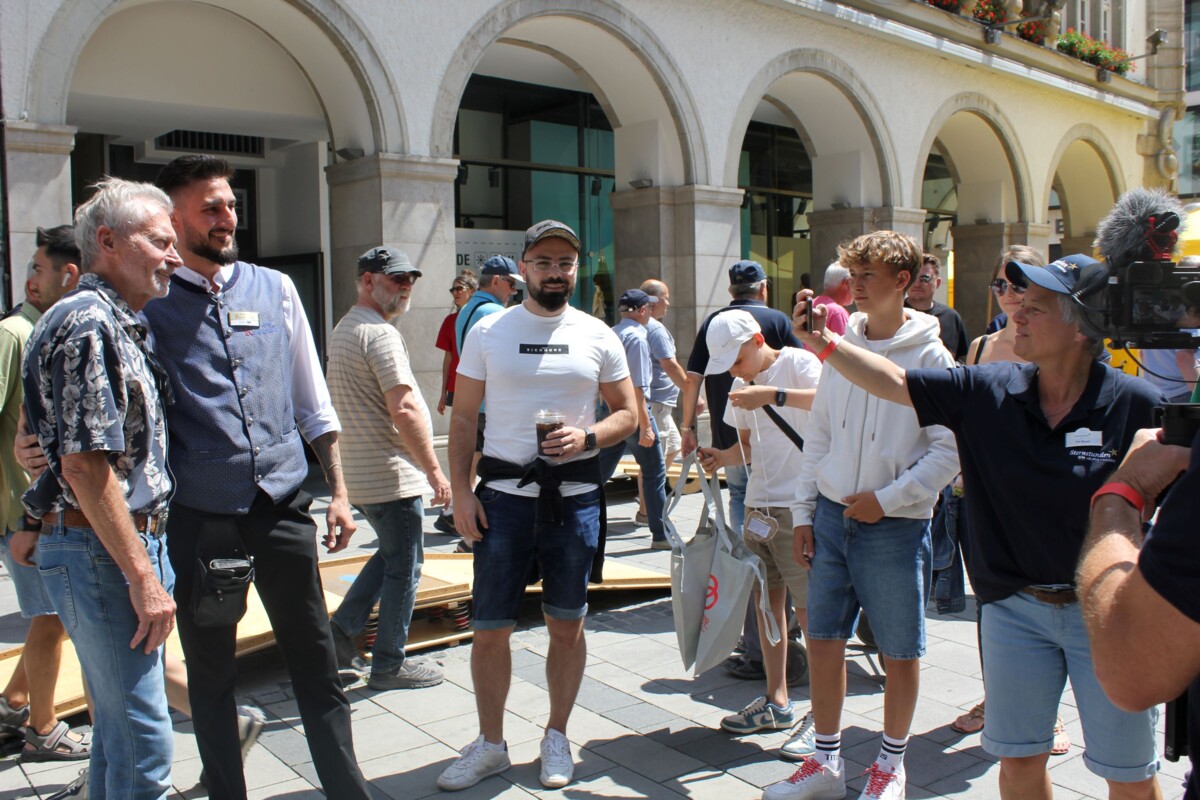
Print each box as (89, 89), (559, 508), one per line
(792, 308), (959, 525)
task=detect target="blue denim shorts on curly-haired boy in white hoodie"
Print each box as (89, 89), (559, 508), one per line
(809, 497), (931, 662)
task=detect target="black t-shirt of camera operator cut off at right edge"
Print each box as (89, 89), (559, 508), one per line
(1138, 435), (1200, 800)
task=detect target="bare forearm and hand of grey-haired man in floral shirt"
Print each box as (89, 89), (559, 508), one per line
(62, 451), (175, 654)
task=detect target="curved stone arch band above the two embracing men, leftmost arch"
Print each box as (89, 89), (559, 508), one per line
(28, 0), (408, 154)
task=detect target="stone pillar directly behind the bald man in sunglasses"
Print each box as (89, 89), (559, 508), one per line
(611, 186), (743, 363)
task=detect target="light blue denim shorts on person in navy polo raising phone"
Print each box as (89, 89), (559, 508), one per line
(984, 593), (1158, 783)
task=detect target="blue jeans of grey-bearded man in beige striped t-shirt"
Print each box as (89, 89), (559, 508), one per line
(334, 498), (425, 673)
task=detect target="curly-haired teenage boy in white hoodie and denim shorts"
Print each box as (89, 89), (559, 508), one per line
(763, 230), (959, 800)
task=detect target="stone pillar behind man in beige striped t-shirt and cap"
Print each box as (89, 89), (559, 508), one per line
(325, 154), (458, 434)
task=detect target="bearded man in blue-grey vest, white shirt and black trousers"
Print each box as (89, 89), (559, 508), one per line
(145, 156), (371, 800)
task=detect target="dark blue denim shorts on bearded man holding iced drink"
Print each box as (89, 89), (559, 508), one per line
(472, 487), (600, 630)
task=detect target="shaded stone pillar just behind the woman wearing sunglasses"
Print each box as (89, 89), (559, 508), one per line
(950, 222), (1050, 338)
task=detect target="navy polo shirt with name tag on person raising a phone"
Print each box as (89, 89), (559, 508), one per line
(906, 361), (1163, 603)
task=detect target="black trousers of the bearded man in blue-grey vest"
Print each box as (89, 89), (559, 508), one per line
(167, 492), (371, 800)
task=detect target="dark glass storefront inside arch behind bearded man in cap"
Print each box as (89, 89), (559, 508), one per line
(455, 76), (616, 324)
